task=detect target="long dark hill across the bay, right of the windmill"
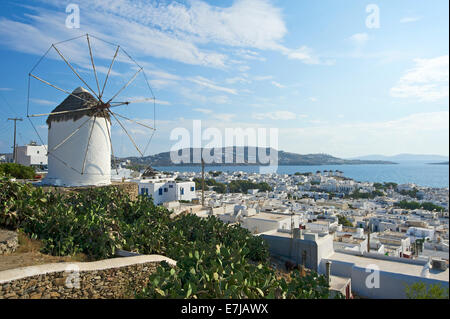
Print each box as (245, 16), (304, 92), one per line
(121, 147), (396, 166)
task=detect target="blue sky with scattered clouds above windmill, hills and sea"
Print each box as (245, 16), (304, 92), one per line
(0, 0), (449, 157)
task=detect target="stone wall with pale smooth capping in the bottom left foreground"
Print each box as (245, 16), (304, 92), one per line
(0, 255), (176, 299)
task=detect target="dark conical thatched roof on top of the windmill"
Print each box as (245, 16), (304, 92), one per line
(46, 87), (110, 128)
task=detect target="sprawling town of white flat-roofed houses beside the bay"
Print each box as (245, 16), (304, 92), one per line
(131, 163), (449, 298)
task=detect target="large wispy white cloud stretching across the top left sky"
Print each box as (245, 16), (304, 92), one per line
(0, 0), (319, 67)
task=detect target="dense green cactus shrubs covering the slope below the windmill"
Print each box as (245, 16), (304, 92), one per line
(0, 178), (328, 298)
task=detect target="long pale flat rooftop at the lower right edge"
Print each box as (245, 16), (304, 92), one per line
(327, 252), (449, 282)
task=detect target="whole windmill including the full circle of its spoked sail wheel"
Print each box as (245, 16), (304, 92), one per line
(27, 34), (156, 186)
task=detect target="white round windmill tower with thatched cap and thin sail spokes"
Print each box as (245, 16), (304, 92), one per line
(27, 34), (155, 186)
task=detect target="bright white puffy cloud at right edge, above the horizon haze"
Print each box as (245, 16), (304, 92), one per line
(390, 55), (449, 101)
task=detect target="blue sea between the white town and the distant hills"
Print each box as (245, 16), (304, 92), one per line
(154, 161), (449, 188)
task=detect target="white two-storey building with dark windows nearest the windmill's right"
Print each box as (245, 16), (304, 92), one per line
(138, 178), (197, 205)
